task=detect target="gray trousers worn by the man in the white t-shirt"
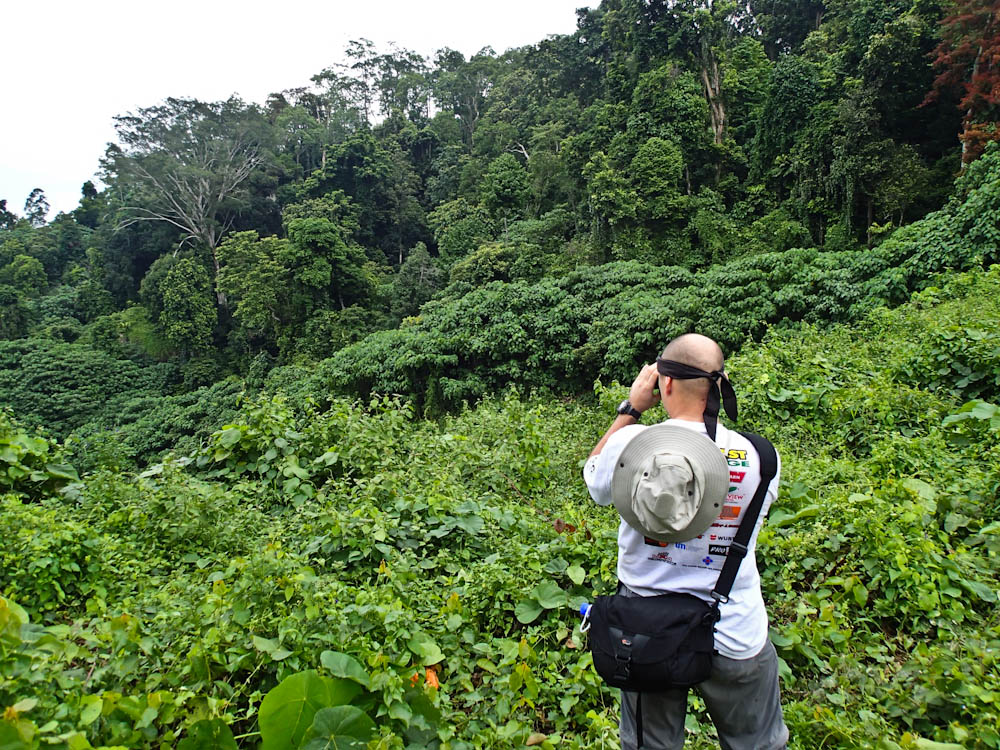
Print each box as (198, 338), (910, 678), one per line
(621, 641), (788, 750)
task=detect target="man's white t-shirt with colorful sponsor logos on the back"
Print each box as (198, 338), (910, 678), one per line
(583, 419), (781, 659)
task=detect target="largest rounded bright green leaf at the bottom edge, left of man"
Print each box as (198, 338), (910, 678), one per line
(258, 670), (361, 750)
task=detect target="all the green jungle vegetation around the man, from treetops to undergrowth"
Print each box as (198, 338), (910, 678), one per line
(0, 0), (1000, 750)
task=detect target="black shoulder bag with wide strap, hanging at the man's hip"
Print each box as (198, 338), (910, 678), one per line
(589, 432), (778, 692)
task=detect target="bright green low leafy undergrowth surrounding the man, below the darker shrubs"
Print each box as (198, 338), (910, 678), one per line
(0, 268), (1000, 750)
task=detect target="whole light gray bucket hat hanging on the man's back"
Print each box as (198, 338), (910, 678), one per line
(611, 424), (729, 542)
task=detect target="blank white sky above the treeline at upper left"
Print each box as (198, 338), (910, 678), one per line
(0, 0), (599, 219)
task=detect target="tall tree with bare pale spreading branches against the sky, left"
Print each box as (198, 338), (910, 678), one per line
(103, 97), (264, 305)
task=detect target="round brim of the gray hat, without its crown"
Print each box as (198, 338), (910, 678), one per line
(611, 424), (729, 542)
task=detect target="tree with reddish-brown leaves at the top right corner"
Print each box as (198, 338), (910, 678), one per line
(926, 0), (1000, 164)
